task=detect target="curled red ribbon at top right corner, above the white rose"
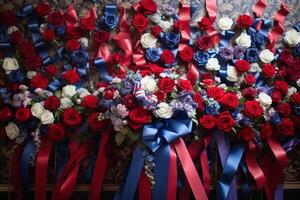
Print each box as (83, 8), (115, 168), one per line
(267, 2), (290, 51)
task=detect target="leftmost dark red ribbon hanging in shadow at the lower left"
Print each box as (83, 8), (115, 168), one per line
(10, 145), (24, 200)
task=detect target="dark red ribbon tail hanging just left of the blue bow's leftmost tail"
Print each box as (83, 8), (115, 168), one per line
(89, 133), (109, 200)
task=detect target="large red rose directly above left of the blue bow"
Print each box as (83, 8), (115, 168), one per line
(128, 107), (151, 130)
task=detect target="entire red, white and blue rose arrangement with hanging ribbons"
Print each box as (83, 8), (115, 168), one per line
(0, 0), (300, 199)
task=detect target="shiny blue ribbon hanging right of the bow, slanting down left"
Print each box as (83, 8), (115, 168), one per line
(217, 142), (244, 200)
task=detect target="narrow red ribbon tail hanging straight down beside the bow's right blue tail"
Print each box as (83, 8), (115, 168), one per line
(167, 144), (177, 200)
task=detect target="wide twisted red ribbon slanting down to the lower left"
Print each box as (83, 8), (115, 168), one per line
(52, 141), (90, 200)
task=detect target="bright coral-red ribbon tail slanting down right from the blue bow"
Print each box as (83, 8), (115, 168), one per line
(174, 138), (208, 200)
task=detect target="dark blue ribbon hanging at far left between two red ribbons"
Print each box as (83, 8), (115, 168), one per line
(20, 137), (35, 188)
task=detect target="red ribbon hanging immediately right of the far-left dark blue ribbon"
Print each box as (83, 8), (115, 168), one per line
(34, 136), (52, 200)
